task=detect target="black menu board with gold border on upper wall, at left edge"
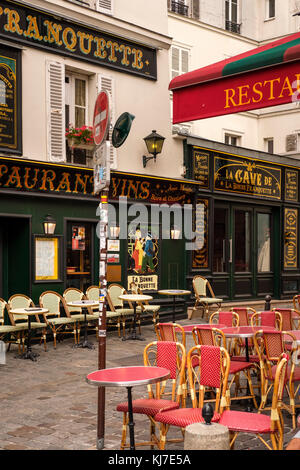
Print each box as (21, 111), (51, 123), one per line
(0, 47), (21, 150)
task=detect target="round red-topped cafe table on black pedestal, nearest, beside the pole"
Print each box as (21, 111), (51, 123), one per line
(86, 366), (170, 450)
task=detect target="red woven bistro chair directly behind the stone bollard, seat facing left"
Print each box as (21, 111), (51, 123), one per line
(155, 345), (230, 450)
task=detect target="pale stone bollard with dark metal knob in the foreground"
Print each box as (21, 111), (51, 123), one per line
(184, 403), (230, 450)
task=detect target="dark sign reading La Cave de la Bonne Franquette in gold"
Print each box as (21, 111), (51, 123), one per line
(214, 155), (281, 199)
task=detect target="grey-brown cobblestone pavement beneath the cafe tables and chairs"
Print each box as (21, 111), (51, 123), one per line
(0, 319), (296, 450)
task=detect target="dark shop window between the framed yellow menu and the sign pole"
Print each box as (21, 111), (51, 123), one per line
(66, 222), (93, 291)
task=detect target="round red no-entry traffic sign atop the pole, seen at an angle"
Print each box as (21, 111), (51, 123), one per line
(93, 91), (110, 146)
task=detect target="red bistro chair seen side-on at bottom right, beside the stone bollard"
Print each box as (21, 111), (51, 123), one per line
(219, 354), (288, 450)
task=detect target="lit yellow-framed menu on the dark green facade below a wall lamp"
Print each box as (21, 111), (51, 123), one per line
(34, 235), (61, 282)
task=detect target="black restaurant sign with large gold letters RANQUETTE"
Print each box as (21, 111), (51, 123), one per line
(0, 0), (157, 80)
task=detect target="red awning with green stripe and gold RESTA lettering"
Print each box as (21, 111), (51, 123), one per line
(169, 33), (300, 124)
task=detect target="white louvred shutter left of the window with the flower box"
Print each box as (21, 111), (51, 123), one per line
(46, 61), (66, 162)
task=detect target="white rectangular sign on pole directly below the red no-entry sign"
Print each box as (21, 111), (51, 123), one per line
(94, 140), (110, 194)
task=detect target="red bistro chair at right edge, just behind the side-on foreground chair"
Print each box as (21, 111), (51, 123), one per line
(254, 331), (300, 429)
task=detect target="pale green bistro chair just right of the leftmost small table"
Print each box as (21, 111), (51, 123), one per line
(39, 290), (77, 349)
